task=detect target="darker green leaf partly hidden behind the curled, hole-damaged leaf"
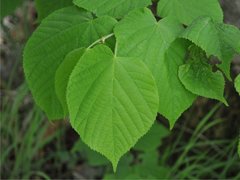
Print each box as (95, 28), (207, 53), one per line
(159, 39), (196, 129)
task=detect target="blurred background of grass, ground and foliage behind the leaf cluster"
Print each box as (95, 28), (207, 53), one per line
(0, 0), (240, 179)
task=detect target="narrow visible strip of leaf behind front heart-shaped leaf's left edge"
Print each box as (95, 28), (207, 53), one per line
(55, 48), (86, 116)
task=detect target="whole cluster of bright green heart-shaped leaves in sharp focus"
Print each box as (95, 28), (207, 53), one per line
(24, 0), (240, 170)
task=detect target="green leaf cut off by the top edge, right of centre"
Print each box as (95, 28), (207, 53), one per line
(157, 0), (223, 25)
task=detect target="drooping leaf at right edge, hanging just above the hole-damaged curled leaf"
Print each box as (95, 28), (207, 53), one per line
(181, 17), (240, 79)
